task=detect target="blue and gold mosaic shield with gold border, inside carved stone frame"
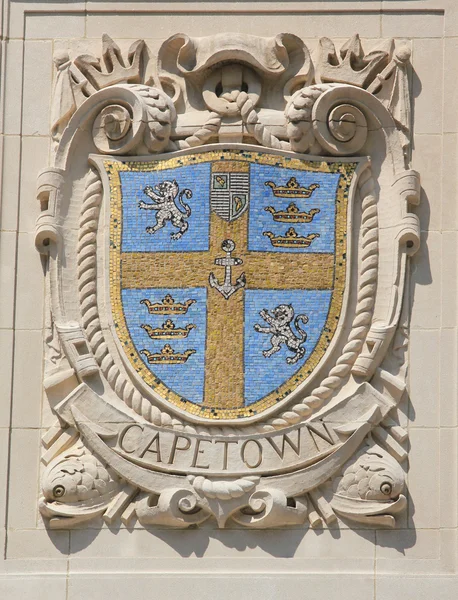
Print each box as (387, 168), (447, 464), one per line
(96, 148), (362, 419)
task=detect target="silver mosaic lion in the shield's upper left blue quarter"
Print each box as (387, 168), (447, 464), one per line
(138, 180), (192, 240)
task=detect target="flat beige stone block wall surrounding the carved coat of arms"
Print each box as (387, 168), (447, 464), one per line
(0, 0), (458, 600)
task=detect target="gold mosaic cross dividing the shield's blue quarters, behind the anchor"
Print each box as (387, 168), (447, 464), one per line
(122, 207), (334, 409)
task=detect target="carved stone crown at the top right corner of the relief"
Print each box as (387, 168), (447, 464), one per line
(316, 34), (392, 88)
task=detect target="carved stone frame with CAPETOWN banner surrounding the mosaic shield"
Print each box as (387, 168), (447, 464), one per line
(36, 34), (420, 528)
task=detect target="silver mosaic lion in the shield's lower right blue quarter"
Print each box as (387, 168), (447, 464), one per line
(254, 304), (309, 365)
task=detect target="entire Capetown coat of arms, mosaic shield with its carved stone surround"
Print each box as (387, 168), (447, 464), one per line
(36, 34), (420, 528)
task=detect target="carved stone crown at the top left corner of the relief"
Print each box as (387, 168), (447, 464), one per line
(75, 33), (145, 90)
